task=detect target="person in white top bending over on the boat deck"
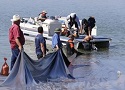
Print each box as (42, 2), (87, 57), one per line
(66, 13), (80, 35)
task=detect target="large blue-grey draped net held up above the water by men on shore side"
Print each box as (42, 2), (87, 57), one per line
(1, 49), (74, 87)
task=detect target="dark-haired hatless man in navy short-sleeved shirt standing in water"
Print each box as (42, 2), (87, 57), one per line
(35, 26), (47, 59)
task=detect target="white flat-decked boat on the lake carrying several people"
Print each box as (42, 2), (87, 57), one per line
(20, 17), (111, 49)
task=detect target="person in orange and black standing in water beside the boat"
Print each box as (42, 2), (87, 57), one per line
(66, 35), (77, 55)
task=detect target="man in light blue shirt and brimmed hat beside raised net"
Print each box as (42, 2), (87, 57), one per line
(52, 28), (62, 50)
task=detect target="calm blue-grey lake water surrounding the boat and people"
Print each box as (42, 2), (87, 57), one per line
(0, 0), (125, 90)
